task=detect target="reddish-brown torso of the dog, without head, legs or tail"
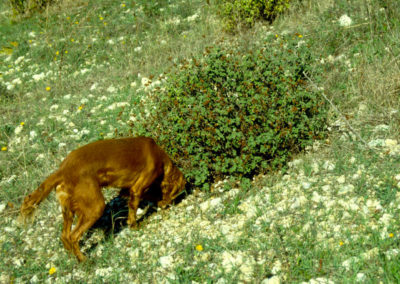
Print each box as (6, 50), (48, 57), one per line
(60, 137), (171, 188)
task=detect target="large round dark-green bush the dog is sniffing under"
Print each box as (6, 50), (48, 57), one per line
(135, 36), (326, 189)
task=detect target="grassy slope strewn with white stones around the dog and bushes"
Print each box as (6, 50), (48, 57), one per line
(0, 0), (400, 283)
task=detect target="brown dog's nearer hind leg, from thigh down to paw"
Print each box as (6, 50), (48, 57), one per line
(70, 179), (105, 261)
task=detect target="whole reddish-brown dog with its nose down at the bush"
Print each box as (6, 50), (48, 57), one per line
(21, 137), (186, 261)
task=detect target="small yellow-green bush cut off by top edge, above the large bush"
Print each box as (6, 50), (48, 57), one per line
(217, 0), (291, 31)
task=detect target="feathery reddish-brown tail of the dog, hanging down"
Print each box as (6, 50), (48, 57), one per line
(19, 171), (62, 223)
